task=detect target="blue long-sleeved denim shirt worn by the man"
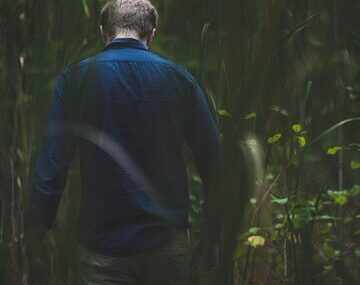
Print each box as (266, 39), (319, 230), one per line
(29, 39), (220, 253)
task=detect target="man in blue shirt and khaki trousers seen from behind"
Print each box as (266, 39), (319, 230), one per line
(27, 0), (220, 285)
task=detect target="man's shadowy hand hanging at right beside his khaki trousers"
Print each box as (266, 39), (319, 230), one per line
(190, 237), (219, 274)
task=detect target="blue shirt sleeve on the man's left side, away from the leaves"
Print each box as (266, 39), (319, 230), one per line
(27, 73), (76, 228)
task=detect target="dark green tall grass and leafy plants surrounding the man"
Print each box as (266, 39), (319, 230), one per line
(0, 0), (360, 285)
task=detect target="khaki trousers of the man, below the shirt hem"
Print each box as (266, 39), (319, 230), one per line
(79, 230), (191, 285)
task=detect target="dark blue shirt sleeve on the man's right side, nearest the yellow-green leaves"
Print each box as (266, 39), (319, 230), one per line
(184, 74), (220, 194)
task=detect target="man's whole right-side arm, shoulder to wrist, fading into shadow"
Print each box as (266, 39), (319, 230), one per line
(185, 77), (222, 244)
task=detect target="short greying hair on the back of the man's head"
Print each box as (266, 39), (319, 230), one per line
(100, 0), (159, 39)
